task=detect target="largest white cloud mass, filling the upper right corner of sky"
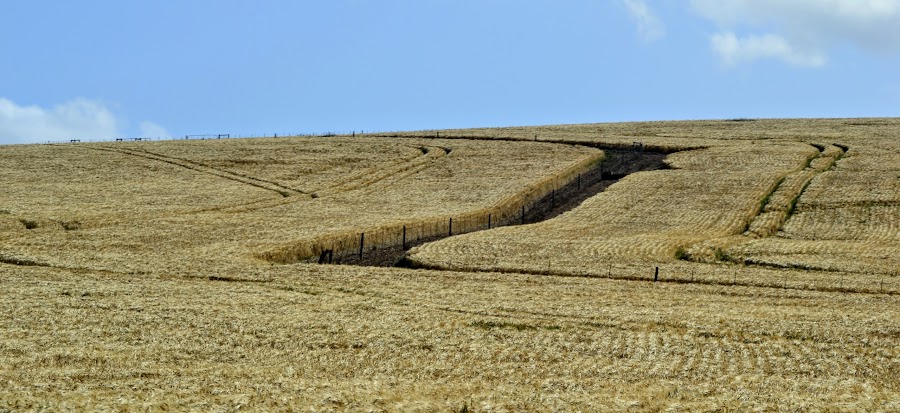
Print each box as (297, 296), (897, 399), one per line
(691, 0), (900, 67)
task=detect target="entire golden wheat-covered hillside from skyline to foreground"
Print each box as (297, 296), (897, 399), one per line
(0, 119), (900, 412)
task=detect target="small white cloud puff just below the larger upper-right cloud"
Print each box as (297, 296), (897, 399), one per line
(712, 32), (826, 67)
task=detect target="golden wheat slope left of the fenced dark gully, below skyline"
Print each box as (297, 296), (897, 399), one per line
(0, 137), (602, 274)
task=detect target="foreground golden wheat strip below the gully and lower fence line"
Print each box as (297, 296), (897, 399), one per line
(0, 264), (900, 411)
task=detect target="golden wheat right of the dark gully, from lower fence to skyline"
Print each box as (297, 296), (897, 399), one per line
(413, 119), (900, 291)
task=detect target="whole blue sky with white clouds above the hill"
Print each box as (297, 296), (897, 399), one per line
(0, 0), (900, 143)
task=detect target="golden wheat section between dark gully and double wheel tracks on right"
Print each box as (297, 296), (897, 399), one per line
(413, 143), (818, 271)
